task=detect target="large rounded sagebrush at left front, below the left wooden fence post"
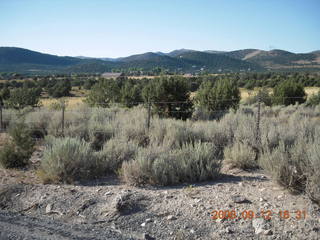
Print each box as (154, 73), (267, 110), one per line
(40, 137), (97, 183)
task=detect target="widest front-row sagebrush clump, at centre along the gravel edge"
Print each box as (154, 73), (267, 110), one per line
(122, 142), (221, 185)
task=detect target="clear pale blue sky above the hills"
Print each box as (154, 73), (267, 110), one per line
(0, 0), (320, 57)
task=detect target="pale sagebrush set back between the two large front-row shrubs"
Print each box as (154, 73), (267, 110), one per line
(99, 138), (138, 173)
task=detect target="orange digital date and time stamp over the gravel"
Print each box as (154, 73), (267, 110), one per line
(210, 209), (307, 220)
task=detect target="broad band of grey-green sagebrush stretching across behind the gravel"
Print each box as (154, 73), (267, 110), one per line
(1, 104), (320, 205)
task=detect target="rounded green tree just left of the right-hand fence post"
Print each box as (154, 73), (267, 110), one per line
(195, 79), (240, 111)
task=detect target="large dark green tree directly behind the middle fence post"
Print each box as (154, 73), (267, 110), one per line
(142, 76), (192, 119)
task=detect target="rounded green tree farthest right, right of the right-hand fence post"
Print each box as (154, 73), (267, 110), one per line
(272, 80), (306, 106)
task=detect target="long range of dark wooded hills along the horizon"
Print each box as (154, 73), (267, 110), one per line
(0, 47), (320, 74)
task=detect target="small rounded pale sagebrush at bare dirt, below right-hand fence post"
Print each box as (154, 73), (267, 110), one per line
(224, 142), (258, 169)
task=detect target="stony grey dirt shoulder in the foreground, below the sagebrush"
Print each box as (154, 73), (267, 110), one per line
(0, 169), (320, 239)
